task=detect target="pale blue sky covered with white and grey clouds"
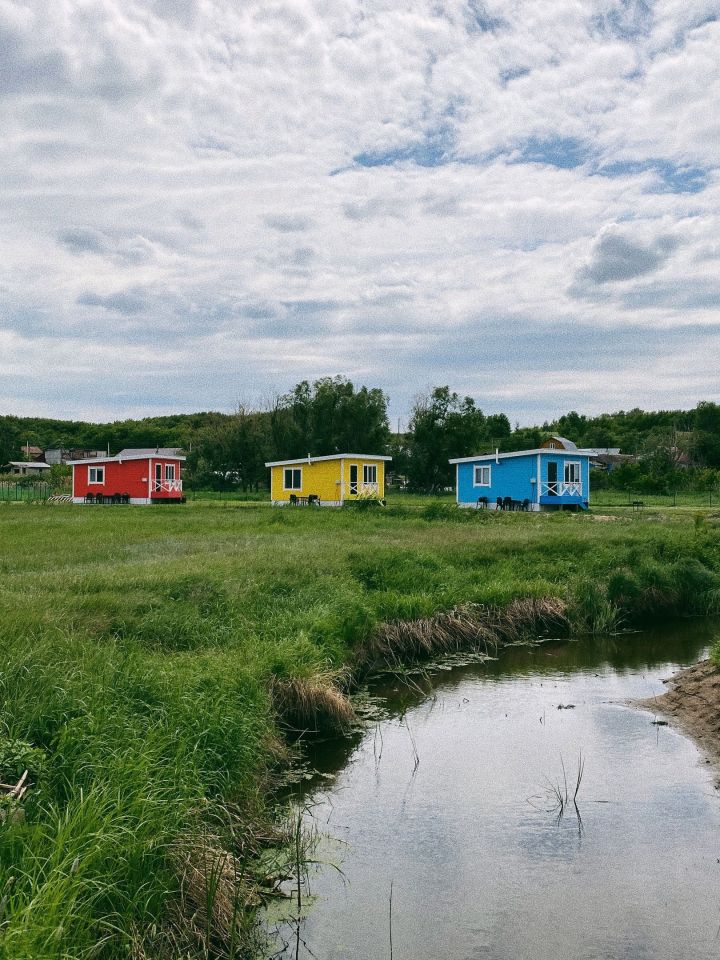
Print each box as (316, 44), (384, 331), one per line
(0, 0), (720, 424)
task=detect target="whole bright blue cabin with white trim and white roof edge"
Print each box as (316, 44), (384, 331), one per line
(450, 448), (590, 511)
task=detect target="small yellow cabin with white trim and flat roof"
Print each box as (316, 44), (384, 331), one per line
(265, 453), (392, 507)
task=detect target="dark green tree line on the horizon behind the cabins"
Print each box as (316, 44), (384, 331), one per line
(0, 376), (720, 492)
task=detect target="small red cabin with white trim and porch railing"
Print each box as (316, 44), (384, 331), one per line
(69, 448), (185, 504)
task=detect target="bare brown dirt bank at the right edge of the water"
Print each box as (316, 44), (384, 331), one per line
(636, 660), (720, 763)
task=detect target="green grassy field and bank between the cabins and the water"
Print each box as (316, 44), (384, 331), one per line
(0, 502), (720, 960)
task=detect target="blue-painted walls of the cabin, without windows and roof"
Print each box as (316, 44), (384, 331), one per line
(457, 450), (590, 506)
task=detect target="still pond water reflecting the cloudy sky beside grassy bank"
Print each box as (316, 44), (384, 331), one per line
(268, 623), (720, 960)
